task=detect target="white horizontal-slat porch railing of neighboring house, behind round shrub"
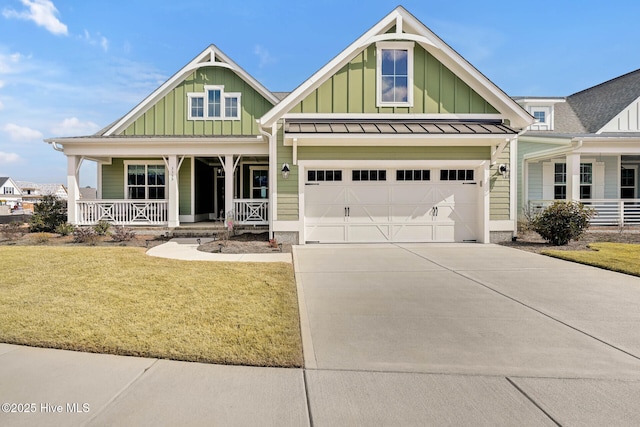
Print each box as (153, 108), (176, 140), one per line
(528, 199), (640, 226)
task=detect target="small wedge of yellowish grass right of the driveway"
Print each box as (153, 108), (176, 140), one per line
(542, 243), (640, 276)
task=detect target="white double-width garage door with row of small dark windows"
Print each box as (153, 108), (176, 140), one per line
(304, 169), (478, 243)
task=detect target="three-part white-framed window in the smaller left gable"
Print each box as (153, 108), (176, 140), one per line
(187, 86), (241, 120)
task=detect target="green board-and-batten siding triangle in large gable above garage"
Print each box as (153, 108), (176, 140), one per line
(290, 45), (498, 114)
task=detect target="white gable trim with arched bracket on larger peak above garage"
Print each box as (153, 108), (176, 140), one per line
(260, 6), (533, 129)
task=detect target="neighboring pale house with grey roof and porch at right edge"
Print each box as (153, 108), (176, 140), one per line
(514, 70), (640, 225)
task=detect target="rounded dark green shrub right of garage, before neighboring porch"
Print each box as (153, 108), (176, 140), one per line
(532, 201), (594, 246)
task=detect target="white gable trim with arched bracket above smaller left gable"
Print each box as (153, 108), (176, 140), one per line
(101, 44), (280, 136)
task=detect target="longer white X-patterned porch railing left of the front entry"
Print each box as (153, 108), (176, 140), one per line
(76, 200), (168, 225)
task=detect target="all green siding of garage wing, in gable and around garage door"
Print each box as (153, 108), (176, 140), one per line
(277, 44), (510, 221)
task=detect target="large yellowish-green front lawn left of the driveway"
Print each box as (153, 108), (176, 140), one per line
(0, 246), (302, 367)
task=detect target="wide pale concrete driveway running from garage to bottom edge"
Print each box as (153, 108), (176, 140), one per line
(294, 244), (640, 425)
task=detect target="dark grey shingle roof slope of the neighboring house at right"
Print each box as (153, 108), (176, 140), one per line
(566, 70), (640, 133)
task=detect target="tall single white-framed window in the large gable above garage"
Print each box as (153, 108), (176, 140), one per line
(376, 42), (413, 107)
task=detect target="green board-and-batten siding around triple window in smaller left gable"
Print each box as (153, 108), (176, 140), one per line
(122, 67), (273, 136)
